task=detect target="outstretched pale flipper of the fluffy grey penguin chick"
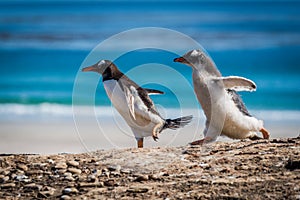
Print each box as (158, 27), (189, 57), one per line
(214, 76), (256, 92)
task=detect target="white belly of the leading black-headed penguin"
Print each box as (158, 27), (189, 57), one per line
(103, 80), (163, 137)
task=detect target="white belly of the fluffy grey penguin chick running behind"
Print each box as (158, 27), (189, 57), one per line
(193, 73), (263, 139)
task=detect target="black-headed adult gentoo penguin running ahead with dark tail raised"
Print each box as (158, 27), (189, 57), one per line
(82, 60), (192, 148)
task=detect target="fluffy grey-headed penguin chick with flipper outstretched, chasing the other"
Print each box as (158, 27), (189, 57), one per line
(174, 50), (269, 145)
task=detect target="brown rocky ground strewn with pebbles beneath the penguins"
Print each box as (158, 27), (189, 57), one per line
(0, 137), (300, 199)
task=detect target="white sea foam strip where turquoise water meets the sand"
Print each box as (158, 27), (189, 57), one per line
(0, 103), (300, 122)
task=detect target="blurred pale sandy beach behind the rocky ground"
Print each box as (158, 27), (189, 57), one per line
(0, 108), (300, 154)
